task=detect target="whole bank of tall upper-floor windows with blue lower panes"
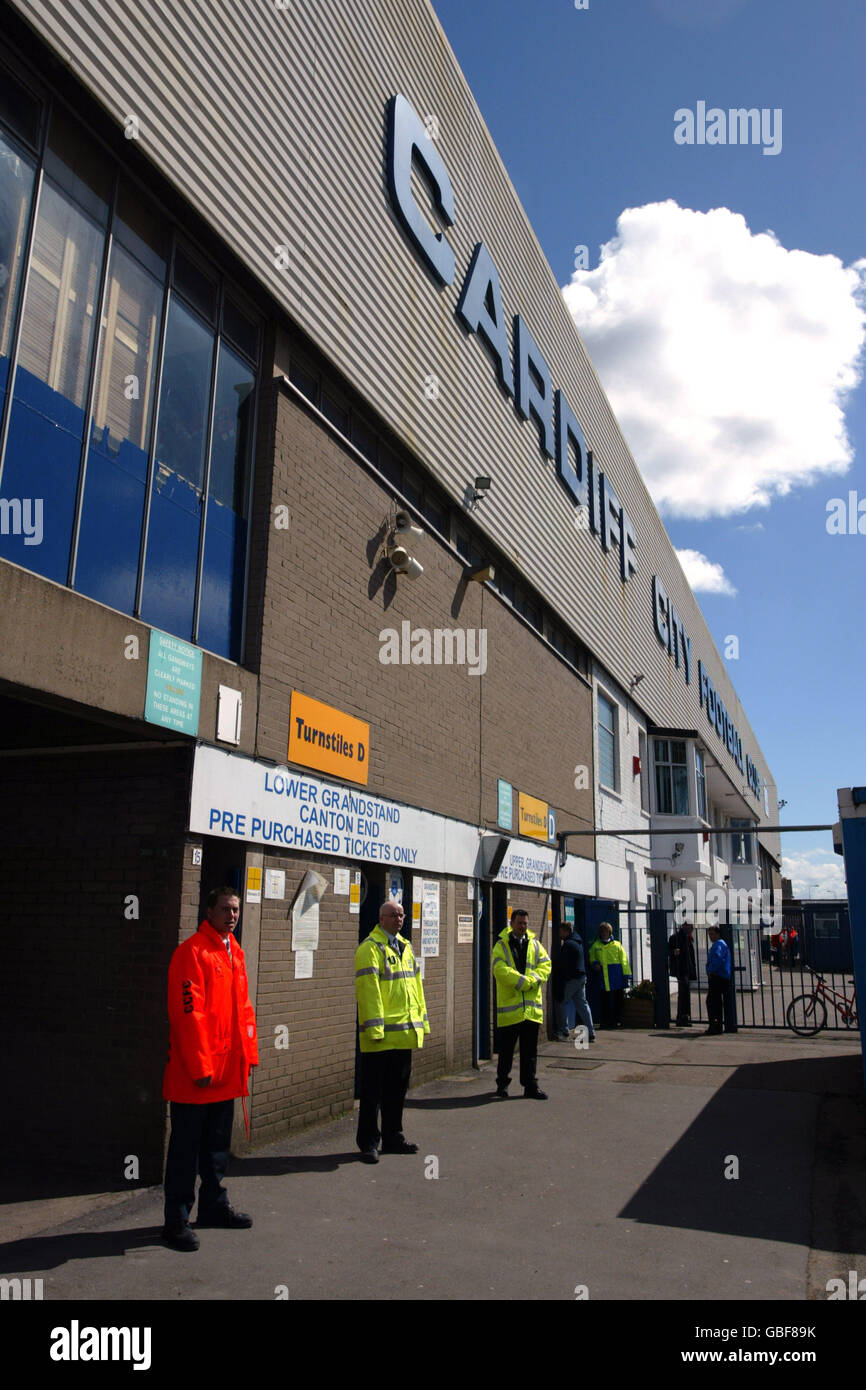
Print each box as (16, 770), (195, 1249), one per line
(0, 89), (260, 660)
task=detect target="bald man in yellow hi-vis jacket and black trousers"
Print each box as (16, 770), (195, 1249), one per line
(354, 901), (430, 1163)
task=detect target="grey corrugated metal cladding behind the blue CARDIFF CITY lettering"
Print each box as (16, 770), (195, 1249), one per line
(8, 0), (776, 839)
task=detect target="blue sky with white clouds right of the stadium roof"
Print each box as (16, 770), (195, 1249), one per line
(434, 0), (866, 897)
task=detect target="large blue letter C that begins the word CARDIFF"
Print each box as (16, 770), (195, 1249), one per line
(388, 96), (455, 285)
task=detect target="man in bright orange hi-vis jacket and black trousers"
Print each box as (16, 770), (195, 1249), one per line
(163, 888), (259, 1250)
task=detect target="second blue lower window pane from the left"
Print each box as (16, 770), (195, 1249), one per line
(75, 430), (147, 613)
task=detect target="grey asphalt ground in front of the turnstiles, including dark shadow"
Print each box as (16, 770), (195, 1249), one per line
(0, 1030), (866, 1318)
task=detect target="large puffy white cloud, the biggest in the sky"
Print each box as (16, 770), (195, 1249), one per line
(563, 199), (866, 517)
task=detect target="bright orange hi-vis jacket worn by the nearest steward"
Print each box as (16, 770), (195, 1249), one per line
(163, 922), (259, 1105)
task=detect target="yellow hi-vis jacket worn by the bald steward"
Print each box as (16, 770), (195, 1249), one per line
(354, 927), (430, 1052)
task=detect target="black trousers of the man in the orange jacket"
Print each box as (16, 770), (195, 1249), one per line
(165, 1101), (235, 1225)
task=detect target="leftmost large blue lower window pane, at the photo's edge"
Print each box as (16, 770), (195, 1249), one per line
(0, 367), (85, 584)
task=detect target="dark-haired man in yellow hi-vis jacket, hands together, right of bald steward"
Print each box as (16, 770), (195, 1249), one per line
(491, 909), (550, 1101)
